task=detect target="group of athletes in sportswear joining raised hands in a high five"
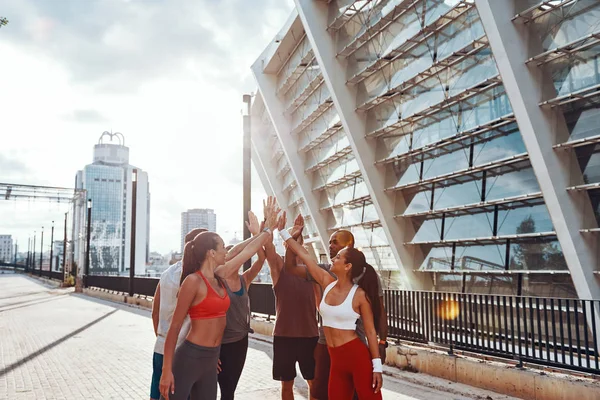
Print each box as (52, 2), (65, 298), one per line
(150, 197), (387, 400)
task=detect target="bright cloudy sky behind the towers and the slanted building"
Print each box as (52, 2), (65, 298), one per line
(0, 0), (293, 254)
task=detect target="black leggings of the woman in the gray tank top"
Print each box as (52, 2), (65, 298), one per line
(218, 336), (248, 400)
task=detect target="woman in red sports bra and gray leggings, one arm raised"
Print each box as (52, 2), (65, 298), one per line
(160, 198), (279, 400)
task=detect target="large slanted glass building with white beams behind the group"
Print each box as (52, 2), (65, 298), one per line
(252, 0), (600, 299)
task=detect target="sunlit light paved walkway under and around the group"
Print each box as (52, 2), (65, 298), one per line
(0, 273), (511, 400)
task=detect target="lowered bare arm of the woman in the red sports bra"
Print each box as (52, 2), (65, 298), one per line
(160, 274), (199, 400)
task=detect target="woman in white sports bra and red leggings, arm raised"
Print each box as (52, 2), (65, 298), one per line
(280, 227), (383, 400)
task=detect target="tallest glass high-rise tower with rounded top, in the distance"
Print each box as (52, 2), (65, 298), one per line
(74, 132), (150, 275)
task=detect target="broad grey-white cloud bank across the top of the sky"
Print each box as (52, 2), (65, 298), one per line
(3, 0), (290, 92)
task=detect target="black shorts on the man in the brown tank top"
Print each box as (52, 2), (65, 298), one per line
(273, 336), (319, 381)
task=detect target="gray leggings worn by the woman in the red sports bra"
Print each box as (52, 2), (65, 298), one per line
(161, 340), (221, 400)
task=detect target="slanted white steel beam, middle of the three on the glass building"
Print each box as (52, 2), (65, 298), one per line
(295, 0), (430, 289)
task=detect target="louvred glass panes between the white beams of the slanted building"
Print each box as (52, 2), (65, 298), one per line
(255, 0), (600, 297)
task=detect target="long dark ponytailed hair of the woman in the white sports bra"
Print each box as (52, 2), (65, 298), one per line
(344, 247), (381, 331)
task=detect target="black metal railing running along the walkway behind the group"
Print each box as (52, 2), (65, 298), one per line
(58, 276), (600, 374)
